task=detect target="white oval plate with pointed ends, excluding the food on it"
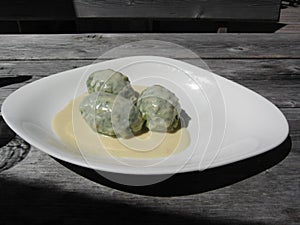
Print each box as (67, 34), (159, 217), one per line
(2, 56), (288, 175)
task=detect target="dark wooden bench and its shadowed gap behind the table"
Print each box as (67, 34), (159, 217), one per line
(0, 0), (288, 33)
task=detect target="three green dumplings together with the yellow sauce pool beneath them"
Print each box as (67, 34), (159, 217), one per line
(53, 69), (190, 159)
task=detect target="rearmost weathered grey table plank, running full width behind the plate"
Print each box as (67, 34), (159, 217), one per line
(0, 34), (300, 60)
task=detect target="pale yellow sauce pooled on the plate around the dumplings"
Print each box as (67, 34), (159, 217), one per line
(52, 87), (190, 159)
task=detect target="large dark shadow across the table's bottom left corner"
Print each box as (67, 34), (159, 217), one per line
(0, 178), (264, 225)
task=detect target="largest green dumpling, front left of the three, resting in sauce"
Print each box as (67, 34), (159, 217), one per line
(80, 92), (144, 138)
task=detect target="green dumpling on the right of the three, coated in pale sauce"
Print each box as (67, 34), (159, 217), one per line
(137, 85), (181, 132)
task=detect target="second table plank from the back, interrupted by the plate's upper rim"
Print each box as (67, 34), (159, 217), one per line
(0, 59), (300, 80)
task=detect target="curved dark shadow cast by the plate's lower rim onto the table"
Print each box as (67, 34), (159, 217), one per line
(56, 136), (292, 196)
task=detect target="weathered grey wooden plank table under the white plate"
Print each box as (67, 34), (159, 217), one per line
(0, 34), (300, 225)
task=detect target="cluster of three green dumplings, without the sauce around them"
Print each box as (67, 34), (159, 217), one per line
(80, 69), (181, 138)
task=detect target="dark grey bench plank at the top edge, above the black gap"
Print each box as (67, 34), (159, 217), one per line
(74, 0), (280, 21)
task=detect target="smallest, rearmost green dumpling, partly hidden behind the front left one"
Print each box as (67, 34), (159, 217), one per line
(86, 69), (139, 102)
